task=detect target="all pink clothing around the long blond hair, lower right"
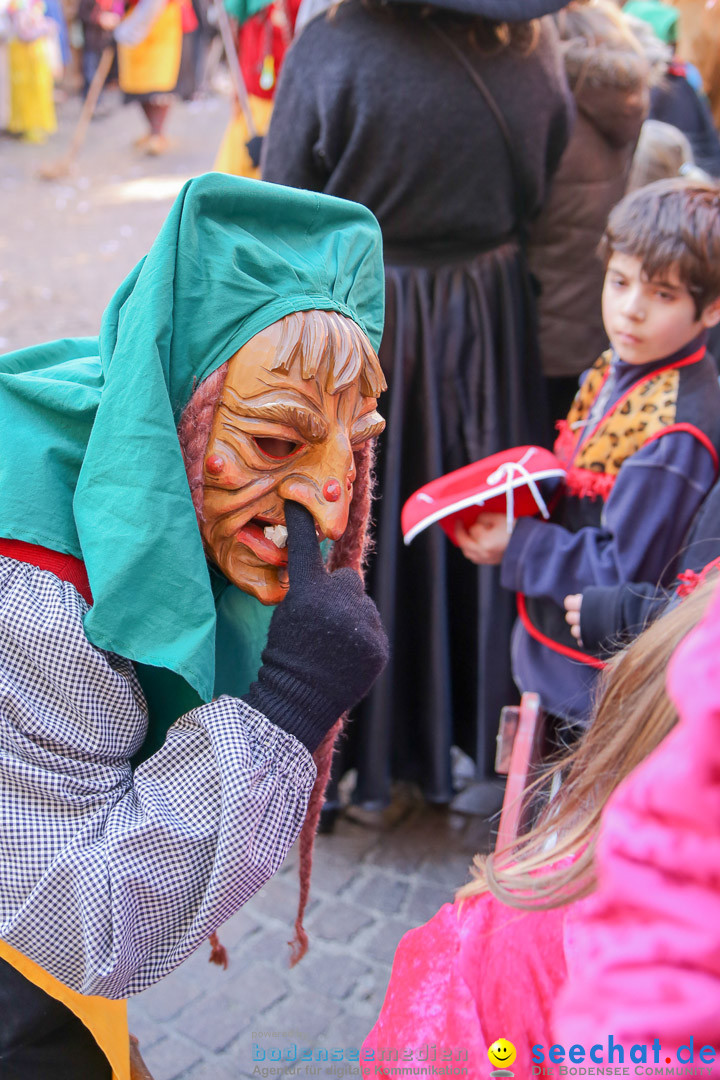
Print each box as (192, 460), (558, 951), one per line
(361, 590), (720, 1080)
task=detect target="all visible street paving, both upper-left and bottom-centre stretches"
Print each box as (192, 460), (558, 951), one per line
(0, 94), (507, 1080)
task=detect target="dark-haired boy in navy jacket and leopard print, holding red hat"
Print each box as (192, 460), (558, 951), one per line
(457, 179), (720, 724)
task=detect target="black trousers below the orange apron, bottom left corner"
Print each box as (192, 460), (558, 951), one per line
(0, 960), (112, 1080)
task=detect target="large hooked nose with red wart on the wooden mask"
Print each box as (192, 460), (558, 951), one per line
(277, 436), (355, 540)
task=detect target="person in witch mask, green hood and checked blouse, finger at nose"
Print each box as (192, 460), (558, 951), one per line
(0, 175), (386, 1080)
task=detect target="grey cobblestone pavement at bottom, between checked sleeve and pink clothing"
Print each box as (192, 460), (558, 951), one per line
(130, 804), (505, 1080)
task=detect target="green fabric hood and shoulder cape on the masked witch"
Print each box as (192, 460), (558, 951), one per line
(0, 174), (384, 718)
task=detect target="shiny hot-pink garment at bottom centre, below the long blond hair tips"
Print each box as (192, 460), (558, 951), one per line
(361, 893), (566, 1080)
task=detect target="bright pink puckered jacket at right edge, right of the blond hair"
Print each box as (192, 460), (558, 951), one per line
(555, 589), (720, 1067)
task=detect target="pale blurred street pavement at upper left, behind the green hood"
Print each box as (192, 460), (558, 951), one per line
(0, 92), (230, 352)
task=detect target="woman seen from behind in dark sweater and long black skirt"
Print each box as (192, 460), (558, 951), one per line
(262, 0), (571, 807)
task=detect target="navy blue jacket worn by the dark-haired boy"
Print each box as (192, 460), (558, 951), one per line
(501, 340), (720, 723)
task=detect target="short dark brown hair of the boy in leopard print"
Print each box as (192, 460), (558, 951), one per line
(599, 177), (720, 319)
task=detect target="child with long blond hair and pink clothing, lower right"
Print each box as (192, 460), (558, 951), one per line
(361, 578), (720, 1080)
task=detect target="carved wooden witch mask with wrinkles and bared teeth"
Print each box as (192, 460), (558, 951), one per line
(201, 311), (385, 604)
